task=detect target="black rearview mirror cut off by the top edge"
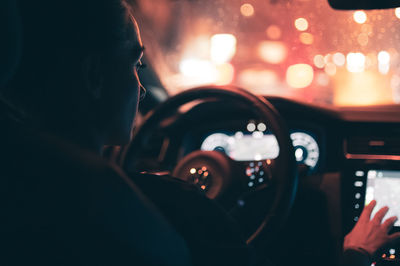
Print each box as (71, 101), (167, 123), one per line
(328, 0), (400, 10)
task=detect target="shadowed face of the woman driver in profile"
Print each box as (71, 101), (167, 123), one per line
(99, 16), (144, 145)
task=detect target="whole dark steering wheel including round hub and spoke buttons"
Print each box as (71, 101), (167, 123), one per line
(122, 86), (297, 248)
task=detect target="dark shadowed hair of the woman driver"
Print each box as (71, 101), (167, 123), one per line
(3, 0), (129, 124)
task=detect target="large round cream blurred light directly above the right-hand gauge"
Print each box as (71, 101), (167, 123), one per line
(286, 64), (314, 89)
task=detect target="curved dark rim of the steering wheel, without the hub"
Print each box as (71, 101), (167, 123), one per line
(122, 86), (298, 244)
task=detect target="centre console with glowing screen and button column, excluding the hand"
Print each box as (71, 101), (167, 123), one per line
(341, 158), (400, 264)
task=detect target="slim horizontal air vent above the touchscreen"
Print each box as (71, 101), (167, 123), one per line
(345, 137), (400, 156)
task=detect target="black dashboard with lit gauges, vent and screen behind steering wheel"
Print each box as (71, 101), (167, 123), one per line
(135, 97), (400, 262)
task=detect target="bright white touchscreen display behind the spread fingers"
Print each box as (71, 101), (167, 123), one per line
(365, 170), (400, 226)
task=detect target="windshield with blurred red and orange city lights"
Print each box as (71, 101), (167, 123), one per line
(130, 0), (400, 106)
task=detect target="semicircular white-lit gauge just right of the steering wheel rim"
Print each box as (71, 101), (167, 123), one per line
(290, 132), (319, 169)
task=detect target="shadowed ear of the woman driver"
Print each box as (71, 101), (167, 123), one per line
(82, 54), (104, 100)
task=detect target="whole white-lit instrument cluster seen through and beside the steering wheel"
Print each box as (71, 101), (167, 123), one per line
(201, 121), (320, 170)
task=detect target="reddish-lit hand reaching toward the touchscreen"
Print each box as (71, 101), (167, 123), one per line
(343, 200), (400, 256)
